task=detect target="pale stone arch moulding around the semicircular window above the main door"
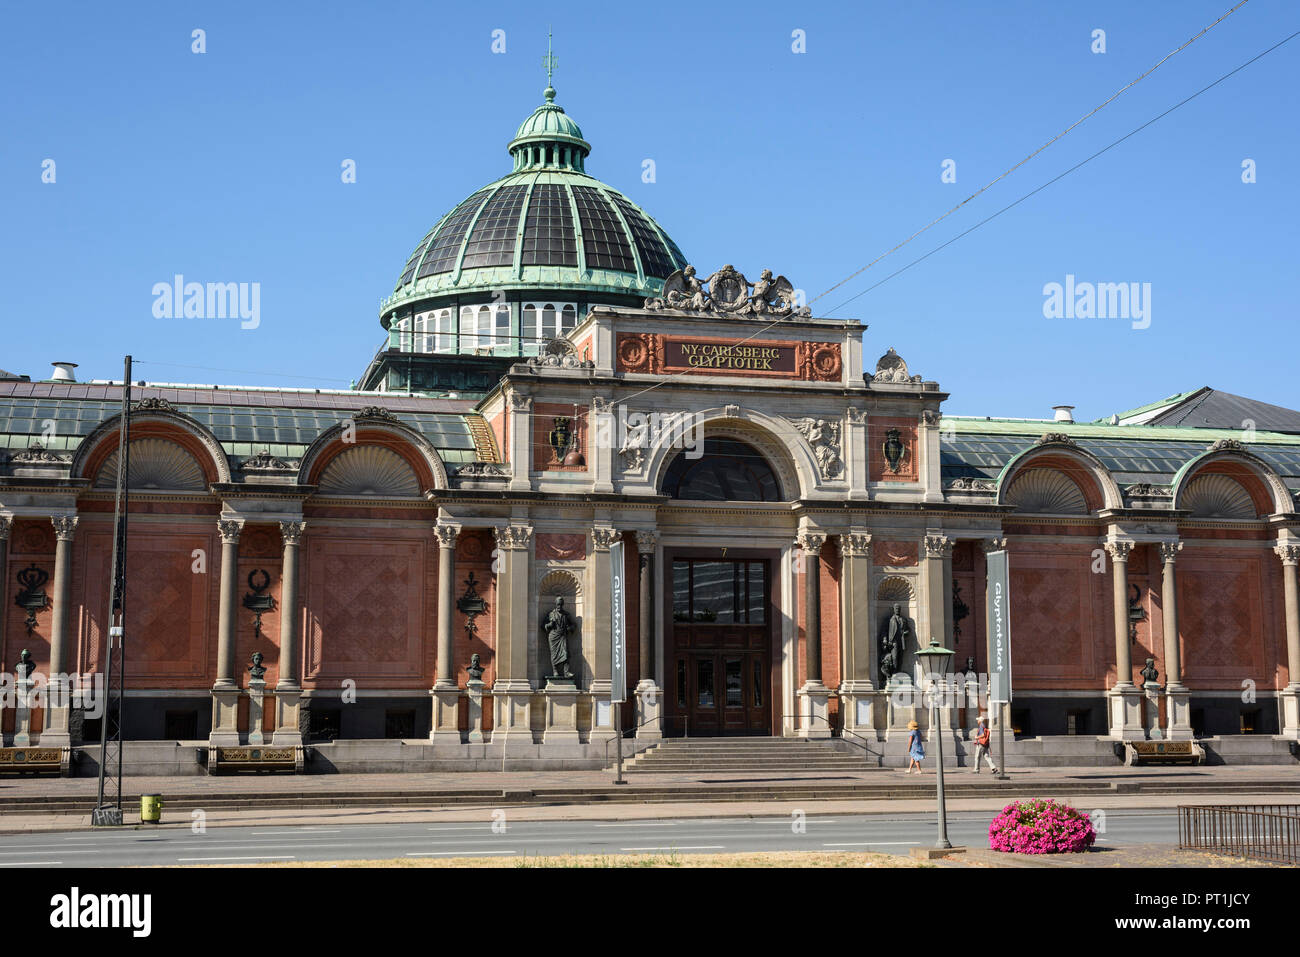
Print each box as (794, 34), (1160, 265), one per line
(646, 408), (818, 502)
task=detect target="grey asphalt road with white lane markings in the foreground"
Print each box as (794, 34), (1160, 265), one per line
(0, 809), (1178, 867)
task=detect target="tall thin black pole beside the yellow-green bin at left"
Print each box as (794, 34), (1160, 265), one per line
(91, 356), (131, 824)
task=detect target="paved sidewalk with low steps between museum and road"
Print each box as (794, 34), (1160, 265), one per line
(0, 767), (1300, 833)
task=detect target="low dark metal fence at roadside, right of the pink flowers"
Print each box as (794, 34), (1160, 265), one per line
(1178, 804), (1300, 863)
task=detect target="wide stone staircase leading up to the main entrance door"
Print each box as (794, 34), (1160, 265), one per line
(625, 737), (878, 774)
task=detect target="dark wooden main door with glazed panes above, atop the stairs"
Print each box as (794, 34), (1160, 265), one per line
(667, 558), (774, 736)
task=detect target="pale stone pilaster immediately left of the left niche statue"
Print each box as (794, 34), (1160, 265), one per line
(491, 525), (533, 750)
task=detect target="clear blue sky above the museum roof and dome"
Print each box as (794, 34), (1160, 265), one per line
(0, 0), (1300, 419)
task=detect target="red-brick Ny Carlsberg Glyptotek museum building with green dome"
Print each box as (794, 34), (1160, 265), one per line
(0, 80), (1300, 774)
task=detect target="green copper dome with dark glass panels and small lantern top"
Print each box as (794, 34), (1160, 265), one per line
(381, 87), (686, 326)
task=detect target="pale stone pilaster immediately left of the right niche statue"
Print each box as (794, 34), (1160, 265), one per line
(840, 529), (883, 740)
